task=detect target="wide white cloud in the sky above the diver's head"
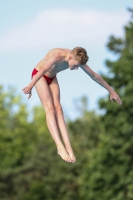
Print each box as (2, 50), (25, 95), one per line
(0, 10), (128, 52)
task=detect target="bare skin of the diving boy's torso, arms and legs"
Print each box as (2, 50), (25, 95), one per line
(22, 48), (122, 162)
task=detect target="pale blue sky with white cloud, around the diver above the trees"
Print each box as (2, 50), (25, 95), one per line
(0, 0), (133, 117)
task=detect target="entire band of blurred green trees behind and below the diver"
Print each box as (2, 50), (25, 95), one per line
(0, 9), (133, 200)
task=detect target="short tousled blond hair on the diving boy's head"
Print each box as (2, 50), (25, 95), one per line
(71, 47), (89, 65)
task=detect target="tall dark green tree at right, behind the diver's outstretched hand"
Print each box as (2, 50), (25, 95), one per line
(80, 9), (133, 200)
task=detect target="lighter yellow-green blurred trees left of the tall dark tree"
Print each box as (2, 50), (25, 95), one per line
(0, 86), (100, 200)
